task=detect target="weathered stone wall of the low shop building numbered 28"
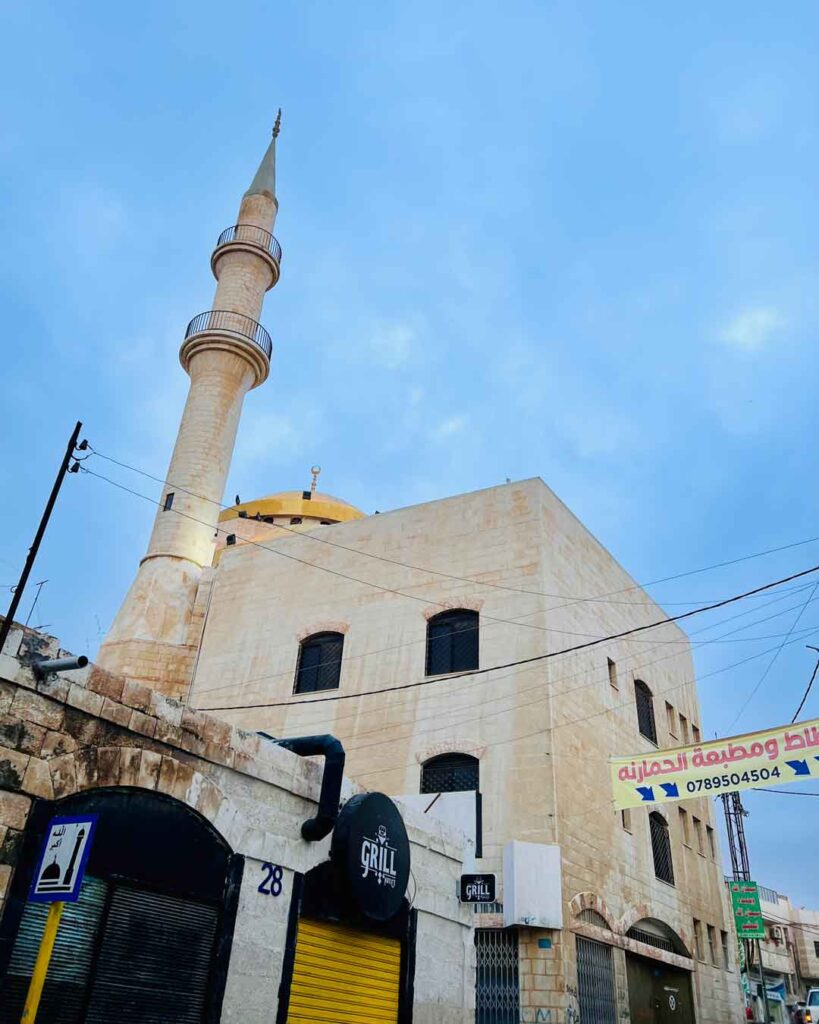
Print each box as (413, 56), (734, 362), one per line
(0, 630), (474, 1024)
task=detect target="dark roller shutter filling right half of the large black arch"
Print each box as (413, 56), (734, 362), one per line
(83, 888), (217, 1024)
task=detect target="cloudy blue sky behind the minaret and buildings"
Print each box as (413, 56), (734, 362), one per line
(0, 0), (819, 906)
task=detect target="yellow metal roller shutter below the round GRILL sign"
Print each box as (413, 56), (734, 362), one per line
(288, 918), (401, 1024)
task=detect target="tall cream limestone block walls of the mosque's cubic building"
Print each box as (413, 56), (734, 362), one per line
(191, 479), (740, 1022)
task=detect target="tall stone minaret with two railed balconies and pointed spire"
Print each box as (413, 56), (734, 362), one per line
(97, 111), (282, 697)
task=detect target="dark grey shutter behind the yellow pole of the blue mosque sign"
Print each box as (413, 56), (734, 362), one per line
(0, 874), (107, 1024)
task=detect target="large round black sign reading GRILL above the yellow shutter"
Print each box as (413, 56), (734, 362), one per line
(330, 793), (410, 921)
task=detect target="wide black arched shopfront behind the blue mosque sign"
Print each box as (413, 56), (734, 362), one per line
(0, 787), (243, 1024)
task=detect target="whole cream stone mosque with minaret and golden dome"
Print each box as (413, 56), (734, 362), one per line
(98, 121), (741, 1024)
